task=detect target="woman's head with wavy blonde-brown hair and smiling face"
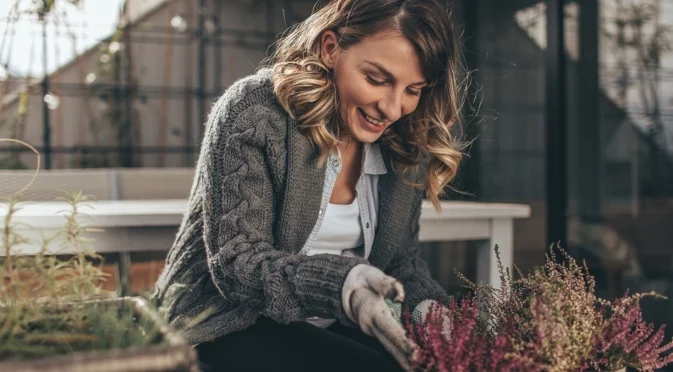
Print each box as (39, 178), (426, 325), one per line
(267, 0), (468, 208)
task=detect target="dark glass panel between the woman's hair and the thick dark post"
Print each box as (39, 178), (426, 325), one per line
(466, 0), (547, 271)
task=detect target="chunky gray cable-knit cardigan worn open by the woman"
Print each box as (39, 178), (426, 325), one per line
(152, 69), (447, 343)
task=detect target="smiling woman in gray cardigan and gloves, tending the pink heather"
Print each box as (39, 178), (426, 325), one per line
(155, 0), (461, 371)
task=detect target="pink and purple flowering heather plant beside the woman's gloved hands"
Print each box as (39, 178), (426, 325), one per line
(405, 246), (673, 372)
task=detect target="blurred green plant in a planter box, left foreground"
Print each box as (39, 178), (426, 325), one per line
(0, 193), (198, 371)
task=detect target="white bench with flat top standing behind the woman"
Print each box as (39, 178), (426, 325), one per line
(0, 199), (530, 294)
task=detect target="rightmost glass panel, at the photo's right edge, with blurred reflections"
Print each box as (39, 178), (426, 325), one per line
(600, 0), (673, 326)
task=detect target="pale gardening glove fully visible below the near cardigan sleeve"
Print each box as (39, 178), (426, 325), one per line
(341, 264), (417, 371)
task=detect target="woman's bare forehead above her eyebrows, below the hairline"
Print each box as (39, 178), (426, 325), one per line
(348, 31), (425, 84)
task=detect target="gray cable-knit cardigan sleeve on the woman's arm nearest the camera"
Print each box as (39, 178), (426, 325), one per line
(199, 100), (365, 323)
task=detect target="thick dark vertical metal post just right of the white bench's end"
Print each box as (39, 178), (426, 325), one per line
(546, 0), (568, 247)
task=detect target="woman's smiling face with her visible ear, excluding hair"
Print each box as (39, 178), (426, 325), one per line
(321, 31), (427, 143)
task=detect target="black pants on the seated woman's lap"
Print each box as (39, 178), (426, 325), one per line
(196, 318), (402, 372)
